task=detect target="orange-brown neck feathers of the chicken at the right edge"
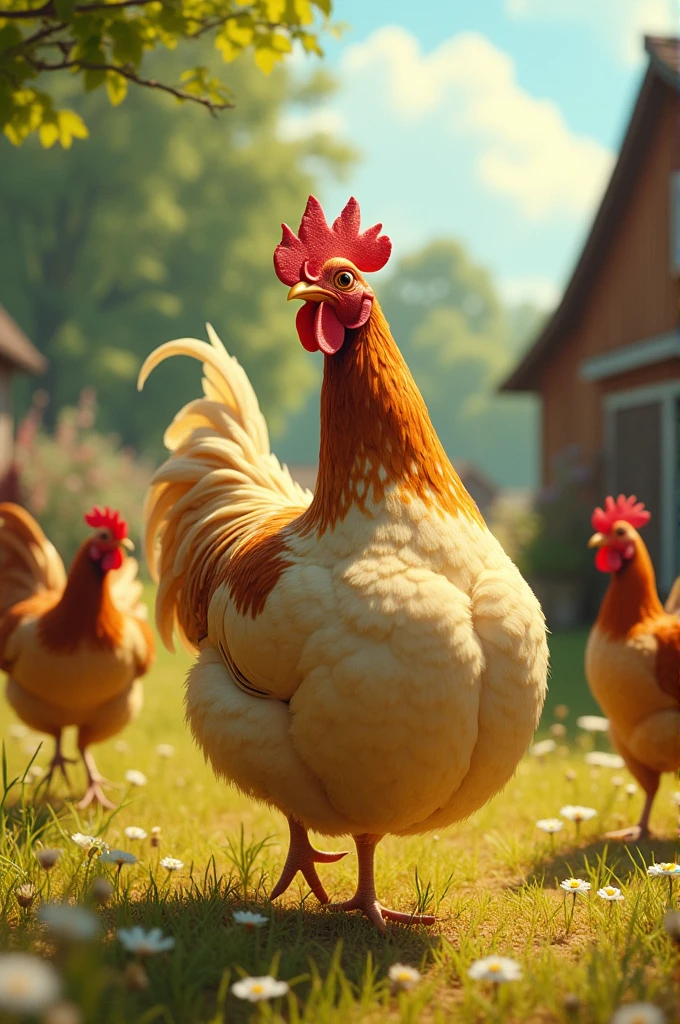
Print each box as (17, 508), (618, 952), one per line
(596, 539), (664, 638)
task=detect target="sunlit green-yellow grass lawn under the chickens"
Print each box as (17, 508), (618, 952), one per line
(0, 606), (680, 1024)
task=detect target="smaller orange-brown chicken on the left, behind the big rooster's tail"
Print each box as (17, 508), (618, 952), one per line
(0, 503), (155, 808)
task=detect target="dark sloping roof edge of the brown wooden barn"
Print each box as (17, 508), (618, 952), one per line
(501, 36), (680, 391)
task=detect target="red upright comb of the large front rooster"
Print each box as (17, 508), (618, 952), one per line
(273, 196), (392, 285)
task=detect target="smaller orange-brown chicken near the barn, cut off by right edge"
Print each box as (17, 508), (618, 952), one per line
(586, 495), (680, 841)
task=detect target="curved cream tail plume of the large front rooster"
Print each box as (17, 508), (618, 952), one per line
(137, 325), (311, 650)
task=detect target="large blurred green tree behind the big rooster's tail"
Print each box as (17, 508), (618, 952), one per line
(0, 53), (350, 454)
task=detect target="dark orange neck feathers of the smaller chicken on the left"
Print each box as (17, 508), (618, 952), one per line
(39, 540), (124, 652)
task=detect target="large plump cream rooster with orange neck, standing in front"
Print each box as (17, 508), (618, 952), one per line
(139, 197), (548, 931)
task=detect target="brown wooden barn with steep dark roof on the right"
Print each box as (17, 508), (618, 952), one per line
(502, 37), (680, 592)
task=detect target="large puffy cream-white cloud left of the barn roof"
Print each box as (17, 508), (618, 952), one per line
(341, 29), (613, 220)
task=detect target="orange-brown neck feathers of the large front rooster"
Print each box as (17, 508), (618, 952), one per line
(301, 301), (482, 534)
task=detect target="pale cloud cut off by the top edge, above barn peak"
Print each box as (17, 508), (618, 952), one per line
(505, 0), (680, 66)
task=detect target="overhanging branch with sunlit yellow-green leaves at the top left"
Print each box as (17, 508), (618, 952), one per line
(0, 0), (332, 148)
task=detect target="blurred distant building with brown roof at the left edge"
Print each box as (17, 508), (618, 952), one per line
(0, 306), (47, 501)
